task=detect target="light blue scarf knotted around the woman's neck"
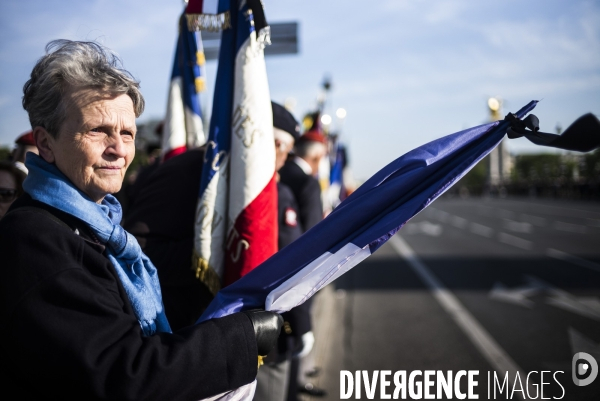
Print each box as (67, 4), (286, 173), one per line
(23, 152), (171, 336)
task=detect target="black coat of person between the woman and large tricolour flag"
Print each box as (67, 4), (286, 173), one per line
(123, 148), (213, 330)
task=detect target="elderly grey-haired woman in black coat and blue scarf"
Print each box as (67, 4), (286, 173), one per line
(0, 40), (281, 400)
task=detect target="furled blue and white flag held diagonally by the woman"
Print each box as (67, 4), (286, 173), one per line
(199, 101), (537, 321)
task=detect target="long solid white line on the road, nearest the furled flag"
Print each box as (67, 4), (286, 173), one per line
(389, 235), (535, 399)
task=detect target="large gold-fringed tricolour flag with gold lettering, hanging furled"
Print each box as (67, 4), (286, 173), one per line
(186, 0), (277, 293)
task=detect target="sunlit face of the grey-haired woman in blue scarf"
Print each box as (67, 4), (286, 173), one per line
(46, 90), (136, 202)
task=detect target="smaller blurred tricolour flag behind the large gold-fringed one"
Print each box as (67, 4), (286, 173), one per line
(162, 15), (206, 161)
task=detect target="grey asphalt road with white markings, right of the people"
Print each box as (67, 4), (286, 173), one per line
(305, 199), (600, 400)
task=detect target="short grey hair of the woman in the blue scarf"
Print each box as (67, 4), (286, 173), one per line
(23, 39), (144, 137)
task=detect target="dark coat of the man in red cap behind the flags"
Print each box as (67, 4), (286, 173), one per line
(279, 160), (323, 232)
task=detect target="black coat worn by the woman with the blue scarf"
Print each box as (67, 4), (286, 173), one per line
(0, 195), (257, 400)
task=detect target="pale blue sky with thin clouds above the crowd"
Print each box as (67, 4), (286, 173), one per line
(0, 0), (600, 180)
